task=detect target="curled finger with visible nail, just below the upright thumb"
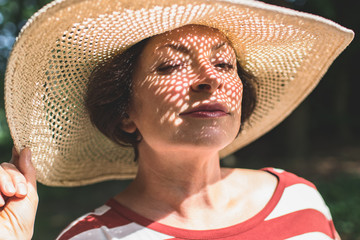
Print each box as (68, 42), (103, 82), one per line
(2, 163), (27, 198)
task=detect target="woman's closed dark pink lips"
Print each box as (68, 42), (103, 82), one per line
(180, 103), (229, 118)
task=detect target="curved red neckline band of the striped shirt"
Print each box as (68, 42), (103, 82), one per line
(106, 168), (285, 239)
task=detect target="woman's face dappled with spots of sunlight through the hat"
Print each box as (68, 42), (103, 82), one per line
(135, 24), (243, 148)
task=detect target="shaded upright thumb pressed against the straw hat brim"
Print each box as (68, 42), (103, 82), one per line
(12, 148), (36, 189)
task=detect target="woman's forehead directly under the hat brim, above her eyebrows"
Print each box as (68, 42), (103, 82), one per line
(148, 25), (229, 49)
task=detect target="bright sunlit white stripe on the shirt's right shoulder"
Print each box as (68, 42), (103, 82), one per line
(265, 183), (331, 220)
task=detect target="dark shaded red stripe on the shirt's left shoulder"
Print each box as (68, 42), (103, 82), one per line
(58, 206), (131, 240)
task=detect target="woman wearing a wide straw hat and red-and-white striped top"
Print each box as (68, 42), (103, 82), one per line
(1, 1), (352, 239)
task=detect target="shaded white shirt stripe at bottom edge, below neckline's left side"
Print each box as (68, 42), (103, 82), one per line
(69, 223), (172, 240)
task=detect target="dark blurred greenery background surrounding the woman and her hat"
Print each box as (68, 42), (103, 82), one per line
(0, 0), (360, 240)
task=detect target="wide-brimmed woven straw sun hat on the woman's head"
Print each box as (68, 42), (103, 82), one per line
(5, 0), (353, 186)
